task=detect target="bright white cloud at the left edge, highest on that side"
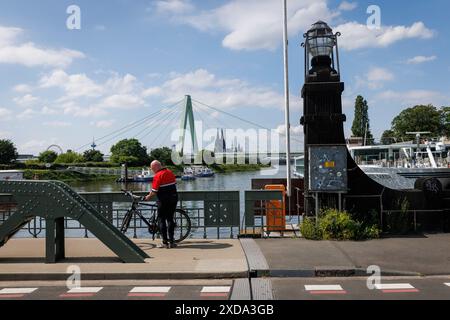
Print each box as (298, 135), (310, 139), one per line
(0, 26), (85, 68)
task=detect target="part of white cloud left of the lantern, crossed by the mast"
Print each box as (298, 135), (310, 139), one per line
(171, 0), (339, 50)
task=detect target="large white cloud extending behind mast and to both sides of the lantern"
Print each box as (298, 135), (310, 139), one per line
(156, 0), (434, 50)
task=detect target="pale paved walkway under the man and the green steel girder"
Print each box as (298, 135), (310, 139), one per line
(0, 239), (248, 280)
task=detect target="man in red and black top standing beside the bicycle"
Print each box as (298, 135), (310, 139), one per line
(144, 160), (178, 249)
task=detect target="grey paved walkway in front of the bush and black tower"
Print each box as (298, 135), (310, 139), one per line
(255, 234), (450, 277)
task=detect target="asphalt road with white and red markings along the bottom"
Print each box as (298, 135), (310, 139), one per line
(0, 276), (450, 301)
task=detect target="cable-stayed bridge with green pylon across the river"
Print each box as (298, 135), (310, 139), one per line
(75, 95), (303, 162)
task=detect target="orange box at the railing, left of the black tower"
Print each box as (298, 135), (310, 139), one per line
(264, 184), (286, 231)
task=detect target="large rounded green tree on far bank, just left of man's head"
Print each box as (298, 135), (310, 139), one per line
(111, 139), (150, 166)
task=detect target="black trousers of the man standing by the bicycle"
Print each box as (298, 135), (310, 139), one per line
(157, 193), (178, 243)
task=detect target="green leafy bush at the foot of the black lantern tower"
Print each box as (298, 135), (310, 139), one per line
(300, 209), (380, 240)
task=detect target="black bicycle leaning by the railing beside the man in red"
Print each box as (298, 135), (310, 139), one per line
(120, 190), (191, 243)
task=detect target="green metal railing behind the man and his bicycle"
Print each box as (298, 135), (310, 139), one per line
(0, 191), (240, 239)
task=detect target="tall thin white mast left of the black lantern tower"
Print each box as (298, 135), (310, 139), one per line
(283, 0), (291, 197)
